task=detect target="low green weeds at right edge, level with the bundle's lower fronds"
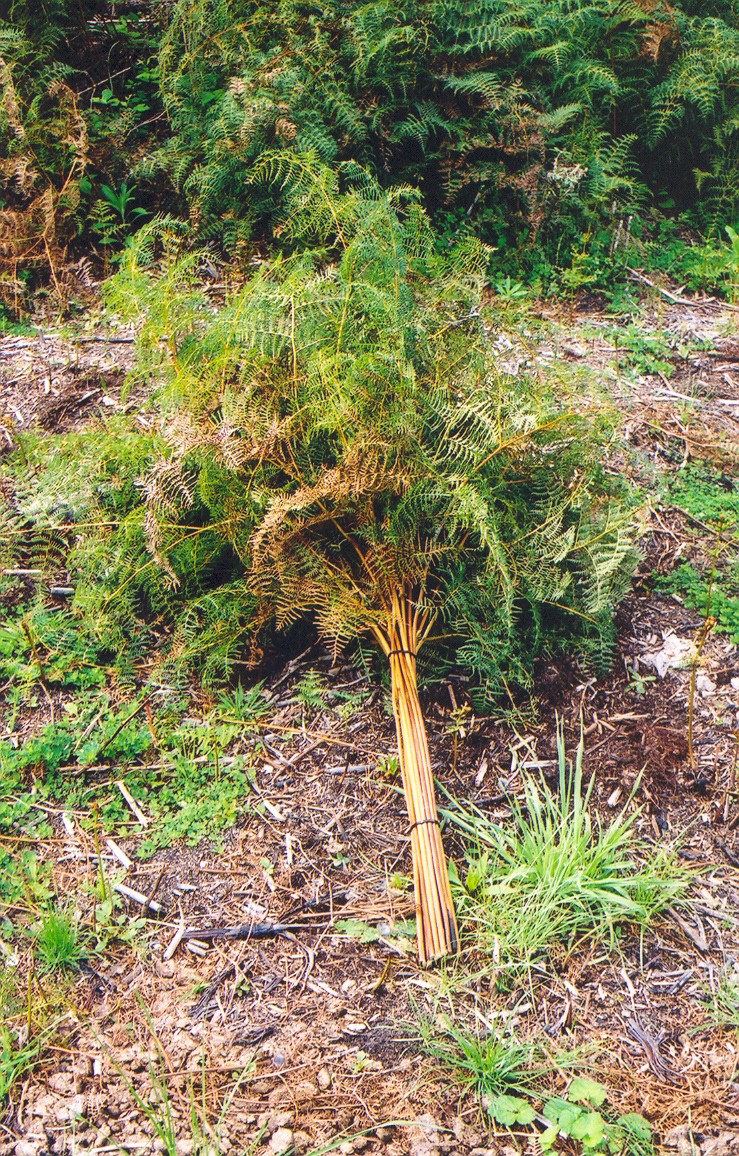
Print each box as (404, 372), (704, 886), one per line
(655, 462), (739, 643)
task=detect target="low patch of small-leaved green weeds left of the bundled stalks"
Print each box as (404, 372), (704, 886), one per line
(0, 692), (257, 858)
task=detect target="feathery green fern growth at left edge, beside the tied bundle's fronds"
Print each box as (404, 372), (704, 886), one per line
(0, 417), (260, 692)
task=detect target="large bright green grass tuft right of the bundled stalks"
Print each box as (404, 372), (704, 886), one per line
(445, 729), (686, 986)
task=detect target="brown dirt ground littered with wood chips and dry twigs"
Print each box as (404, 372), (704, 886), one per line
(0, 299), (739, 1156)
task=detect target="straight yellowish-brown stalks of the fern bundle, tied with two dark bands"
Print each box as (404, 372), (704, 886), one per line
(376, 592), (459, 964)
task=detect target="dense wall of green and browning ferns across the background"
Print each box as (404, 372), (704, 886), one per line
(0, 0), (739, 304)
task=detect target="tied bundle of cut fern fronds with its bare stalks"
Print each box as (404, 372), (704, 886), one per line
(110, 157), (634, 961)
